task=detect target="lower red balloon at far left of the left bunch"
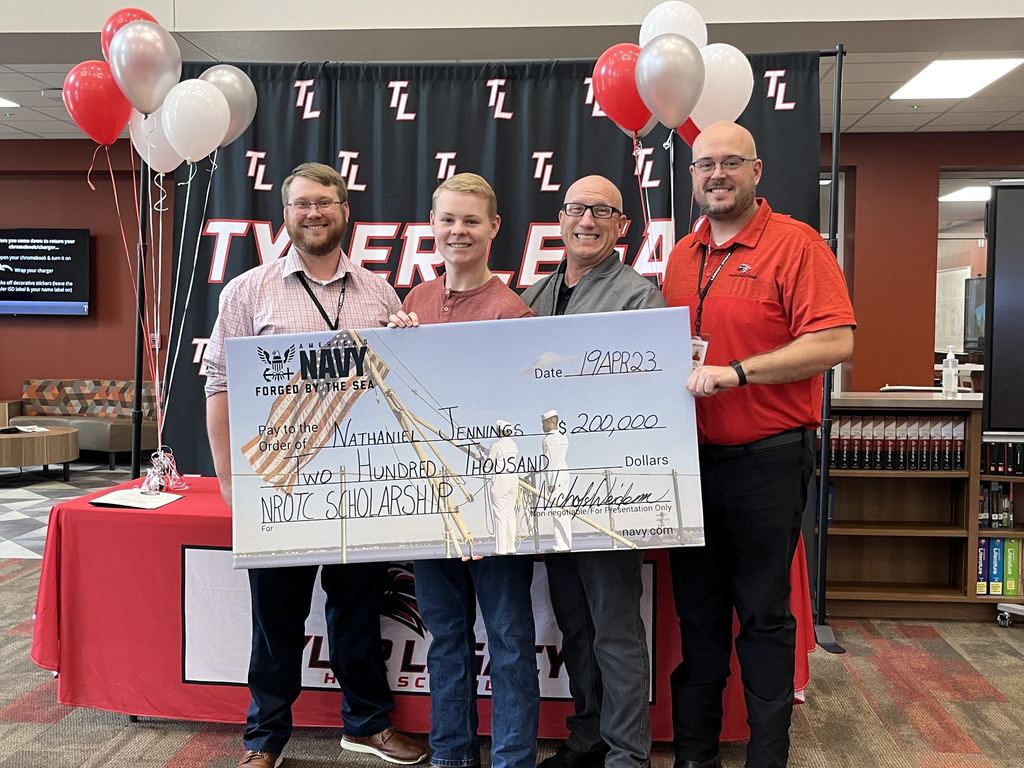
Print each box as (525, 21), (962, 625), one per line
(63, 61), (131, 144)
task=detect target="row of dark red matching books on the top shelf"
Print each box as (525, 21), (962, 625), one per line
(828, 416), (967, 472)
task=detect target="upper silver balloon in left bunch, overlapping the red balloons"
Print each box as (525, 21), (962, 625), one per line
(110, 22), (181, 115)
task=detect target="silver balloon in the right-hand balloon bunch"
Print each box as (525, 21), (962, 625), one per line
(636, 34), (705, 130)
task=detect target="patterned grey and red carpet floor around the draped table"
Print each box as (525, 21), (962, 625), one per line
(0, 465), (1024, 768)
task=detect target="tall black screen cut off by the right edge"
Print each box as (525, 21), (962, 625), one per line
(982, 181), (1024, 432)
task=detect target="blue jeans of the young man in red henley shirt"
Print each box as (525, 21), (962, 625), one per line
(416, 556), (541, 768)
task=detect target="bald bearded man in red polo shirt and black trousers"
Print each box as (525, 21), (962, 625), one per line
(664, 122), (856, 768)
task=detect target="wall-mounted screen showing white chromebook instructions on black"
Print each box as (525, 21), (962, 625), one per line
(0, 229), (89, 316)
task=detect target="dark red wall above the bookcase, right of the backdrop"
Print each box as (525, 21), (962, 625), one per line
(821, 131), (1024, 391)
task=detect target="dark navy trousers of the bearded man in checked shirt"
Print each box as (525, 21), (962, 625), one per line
(244, 563), (394, 754)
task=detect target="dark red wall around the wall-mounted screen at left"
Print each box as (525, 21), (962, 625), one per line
(0, 140), (169, 398)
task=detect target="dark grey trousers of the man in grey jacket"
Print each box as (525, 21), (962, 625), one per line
(544, 550), (650, 768)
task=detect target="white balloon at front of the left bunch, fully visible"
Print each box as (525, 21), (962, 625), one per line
(160, 79), (231, 163)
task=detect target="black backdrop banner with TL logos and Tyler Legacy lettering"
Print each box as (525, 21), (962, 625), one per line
(164, 51), (820, 475)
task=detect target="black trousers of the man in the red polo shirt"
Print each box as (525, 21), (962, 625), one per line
(669, 433), (813, 768)
